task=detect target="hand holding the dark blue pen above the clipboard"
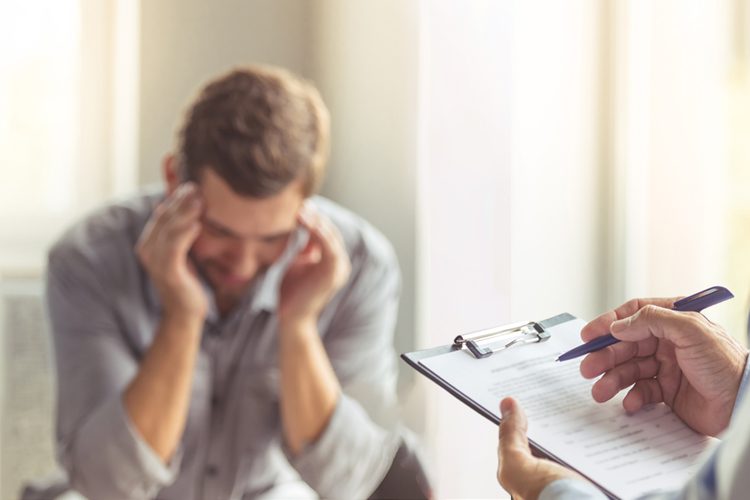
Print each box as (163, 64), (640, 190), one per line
(581, 298), (747, 436)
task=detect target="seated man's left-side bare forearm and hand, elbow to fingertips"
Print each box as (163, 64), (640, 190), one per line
(124, 183), (208, 463)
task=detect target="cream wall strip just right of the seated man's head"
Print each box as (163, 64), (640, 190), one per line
(312, 0), (419, 384)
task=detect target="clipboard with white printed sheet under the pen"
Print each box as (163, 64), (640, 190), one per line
(402, 288), (744, 497)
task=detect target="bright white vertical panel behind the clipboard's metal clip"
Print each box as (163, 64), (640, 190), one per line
(417, 0), (514, 498)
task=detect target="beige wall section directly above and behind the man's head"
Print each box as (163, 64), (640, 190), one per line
(138, 0), (312, 184)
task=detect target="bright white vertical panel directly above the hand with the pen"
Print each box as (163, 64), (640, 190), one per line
(606, 0), (732, 326)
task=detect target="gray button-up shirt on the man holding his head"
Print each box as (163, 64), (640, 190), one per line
(47, 193), (400, 500)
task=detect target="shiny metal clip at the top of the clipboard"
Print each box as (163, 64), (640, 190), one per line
(453, 321), (550, 359)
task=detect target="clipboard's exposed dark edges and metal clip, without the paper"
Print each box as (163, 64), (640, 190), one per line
(401, 313), (619, 499)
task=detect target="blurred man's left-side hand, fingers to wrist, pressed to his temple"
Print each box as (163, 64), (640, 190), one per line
(136, 182), (208, 319)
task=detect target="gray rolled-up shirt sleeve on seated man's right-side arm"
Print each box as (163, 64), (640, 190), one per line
(290, 230), (401, 498)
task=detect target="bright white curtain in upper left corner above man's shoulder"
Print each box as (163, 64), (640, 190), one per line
(0, 0), (138, 275)
